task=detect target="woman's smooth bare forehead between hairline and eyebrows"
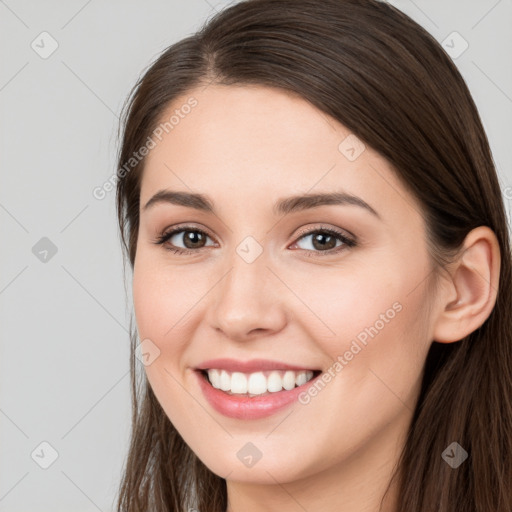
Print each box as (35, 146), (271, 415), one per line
(141, 85), (420, 224)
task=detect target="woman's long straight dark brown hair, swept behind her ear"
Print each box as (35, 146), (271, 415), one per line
(117, 0), (512, 512)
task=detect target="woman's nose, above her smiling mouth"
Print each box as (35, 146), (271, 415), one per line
(210, 247), (287, 341)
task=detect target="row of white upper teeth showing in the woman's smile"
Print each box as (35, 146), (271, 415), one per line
(208, 368), (313, 395)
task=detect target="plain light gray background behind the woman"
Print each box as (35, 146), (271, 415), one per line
(0, 0), (512, 512)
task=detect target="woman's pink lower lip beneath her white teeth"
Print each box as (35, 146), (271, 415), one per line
(195, 370), (321, 420)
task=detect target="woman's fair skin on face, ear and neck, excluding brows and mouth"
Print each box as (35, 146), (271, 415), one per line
(133, 85), (499, 512)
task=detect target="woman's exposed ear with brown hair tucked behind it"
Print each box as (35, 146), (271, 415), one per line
(433, 226), (501, 343)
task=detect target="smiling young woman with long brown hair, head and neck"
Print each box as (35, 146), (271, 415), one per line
(113, 0), (512, 512)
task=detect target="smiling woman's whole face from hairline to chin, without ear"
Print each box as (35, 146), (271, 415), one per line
(133, 85), (438, 483)
